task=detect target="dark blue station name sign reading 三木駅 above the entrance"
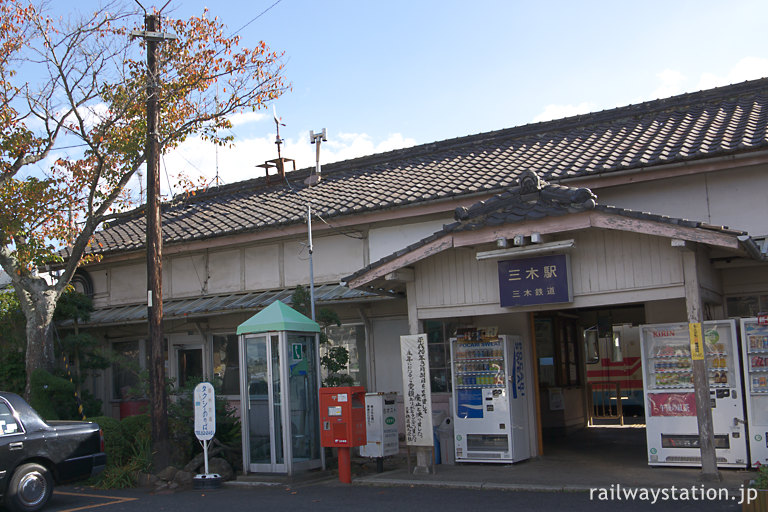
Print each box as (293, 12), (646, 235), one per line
(499, 254), (573, 308)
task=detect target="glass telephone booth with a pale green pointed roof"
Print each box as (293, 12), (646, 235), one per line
(237, 301), (325, 475)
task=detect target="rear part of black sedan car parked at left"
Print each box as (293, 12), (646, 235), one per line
(0, 391), (107, 512)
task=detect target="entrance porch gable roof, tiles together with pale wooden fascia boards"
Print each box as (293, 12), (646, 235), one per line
(344, 171), (766, 290)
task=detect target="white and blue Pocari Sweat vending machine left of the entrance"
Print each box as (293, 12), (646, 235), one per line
(451, 335), (535, 463)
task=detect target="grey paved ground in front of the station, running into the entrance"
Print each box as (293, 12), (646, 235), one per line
(46, 427), (754, 512)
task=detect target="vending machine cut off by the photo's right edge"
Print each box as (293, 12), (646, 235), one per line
(741, 318), (768, 466)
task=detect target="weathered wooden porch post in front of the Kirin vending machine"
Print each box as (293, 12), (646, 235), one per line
(682, 246), (720, 481)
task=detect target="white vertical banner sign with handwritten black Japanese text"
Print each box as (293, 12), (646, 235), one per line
(400, 334), (434, 446)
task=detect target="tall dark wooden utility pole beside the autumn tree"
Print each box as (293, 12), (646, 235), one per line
(131, 9), (176, 471)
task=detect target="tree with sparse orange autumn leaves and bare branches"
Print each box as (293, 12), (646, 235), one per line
(0, 0), (288, 404)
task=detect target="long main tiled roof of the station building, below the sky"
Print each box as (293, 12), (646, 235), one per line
(78, 79), (768, 253)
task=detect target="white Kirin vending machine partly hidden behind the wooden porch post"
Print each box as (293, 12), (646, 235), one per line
(640, 320), (748, 468)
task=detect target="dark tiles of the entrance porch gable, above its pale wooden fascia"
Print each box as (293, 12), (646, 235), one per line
(343, 171), (752, 288)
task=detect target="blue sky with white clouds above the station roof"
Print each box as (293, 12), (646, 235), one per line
(53, 0), (768, 194)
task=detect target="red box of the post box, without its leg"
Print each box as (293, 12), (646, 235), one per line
(320, 386), (367, 448)
